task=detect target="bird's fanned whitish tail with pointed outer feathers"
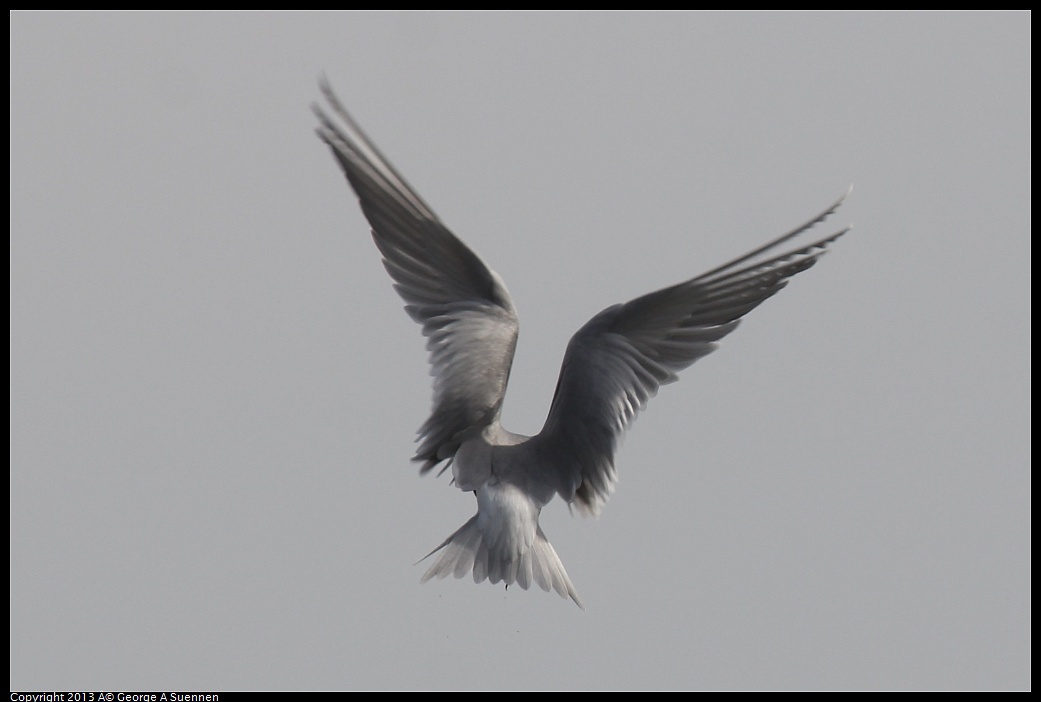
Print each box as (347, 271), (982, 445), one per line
(421, 513), (585, 609)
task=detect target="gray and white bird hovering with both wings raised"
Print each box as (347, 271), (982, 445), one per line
(312, 78), (852, 609)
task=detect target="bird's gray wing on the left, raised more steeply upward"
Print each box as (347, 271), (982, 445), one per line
(314, 81), (517, 473)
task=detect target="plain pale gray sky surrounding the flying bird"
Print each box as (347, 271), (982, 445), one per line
(10, 12), (1031, 690)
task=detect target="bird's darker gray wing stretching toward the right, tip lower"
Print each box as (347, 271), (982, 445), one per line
(537, 196), (848, 515)
